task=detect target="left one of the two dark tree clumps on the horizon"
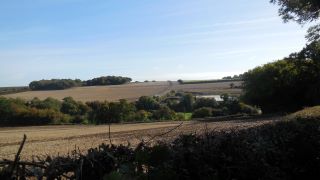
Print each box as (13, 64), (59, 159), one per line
(29, 79), (82, 90)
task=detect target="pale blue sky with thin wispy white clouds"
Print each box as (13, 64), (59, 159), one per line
(0, 0), (307, 86)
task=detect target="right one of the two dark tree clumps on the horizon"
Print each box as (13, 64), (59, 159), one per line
(84, 76), (132, 86)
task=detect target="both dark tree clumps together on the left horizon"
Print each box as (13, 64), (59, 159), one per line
(29, 76), (132, 90)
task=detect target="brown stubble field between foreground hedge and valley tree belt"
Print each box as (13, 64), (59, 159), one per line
(0, 118), (280, 160)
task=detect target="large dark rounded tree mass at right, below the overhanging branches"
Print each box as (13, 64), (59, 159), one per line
(243, 42), (320, 112)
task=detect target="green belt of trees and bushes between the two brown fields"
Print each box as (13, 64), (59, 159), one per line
(0, 92), (259, 125)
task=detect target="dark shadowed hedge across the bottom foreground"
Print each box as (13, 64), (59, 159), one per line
(0, 114), (320, 180)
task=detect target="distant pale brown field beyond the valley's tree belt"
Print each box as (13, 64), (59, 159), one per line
(4, 82), (241, 102)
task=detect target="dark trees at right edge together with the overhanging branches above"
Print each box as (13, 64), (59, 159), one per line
(242, 0), (320, 112)
